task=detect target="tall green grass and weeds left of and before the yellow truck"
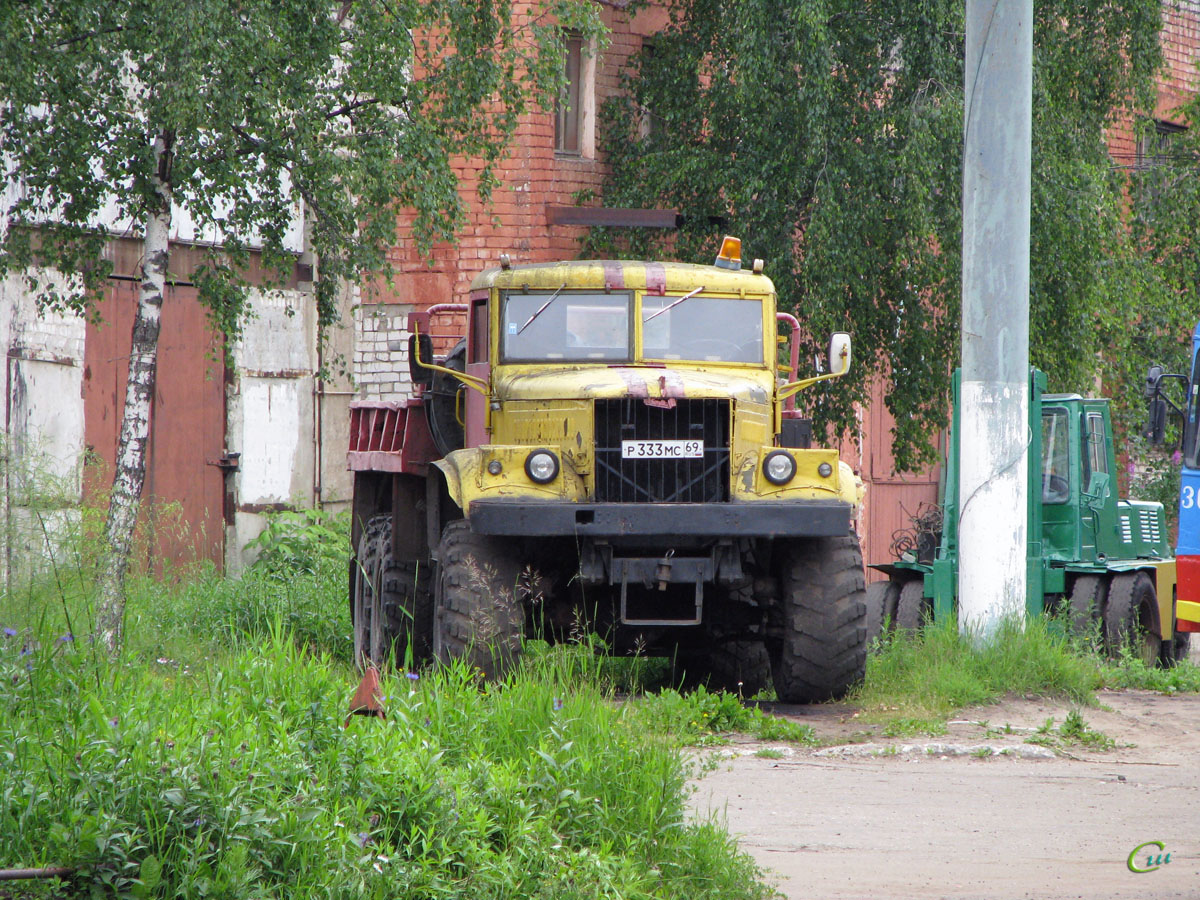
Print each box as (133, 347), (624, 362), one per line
(0, 517), (777, 899)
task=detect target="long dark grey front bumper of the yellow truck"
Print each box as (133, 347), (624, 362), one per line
(468, 500), (851, 538)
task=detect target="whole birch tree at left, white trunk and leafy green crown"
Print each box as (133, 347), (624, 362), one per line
(0, 0), (599, 652)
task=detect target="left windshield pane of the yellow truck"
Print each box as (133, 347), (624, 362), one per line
(500, 292), (632, 362)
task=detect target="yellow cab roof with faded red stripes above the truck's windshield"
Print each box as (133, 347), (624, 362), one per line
(470, 259), (775, 294)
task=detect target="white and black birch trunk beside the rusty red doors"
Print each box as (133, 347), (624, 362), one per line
(96, 132), (174, 654)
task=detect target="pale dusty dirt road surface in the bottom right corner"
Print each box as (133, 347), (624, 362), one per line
(692, 691), (1200, 900)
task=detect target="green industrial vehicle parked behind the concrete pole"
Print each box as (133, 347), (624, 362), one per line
(866, 368), (1187, 664)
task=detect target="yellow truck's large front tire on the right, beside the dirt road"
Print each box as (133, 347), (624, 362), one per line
(770, 534), (866, 703)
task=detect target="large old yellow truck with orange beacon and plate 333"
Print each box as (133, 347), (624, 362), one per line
(349, 239), (866, 702)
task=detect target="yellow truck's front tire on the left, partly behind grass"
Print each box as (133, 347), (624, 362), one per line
(433, 518), (526, 678)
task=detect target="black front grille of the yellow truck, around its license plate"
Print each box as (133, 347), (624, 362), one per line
(595, 397), (730, 503)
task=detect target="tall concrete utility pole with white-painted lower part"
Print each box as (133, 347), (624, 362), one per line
(959, 0), (1033, 640)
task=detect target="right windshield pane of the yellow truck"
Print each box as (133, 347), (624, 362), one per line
(642, 294), (762, 362)
